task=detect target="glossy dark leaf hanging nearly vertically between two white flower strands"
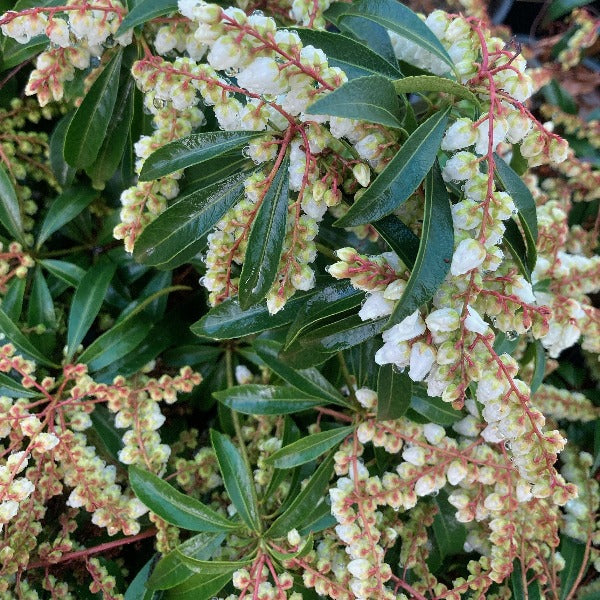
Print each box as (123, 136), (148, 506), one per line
(238, 158), (289, 310)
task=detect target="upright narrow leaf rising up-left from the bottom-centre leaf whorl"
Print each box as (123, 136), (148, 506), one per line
(210, 429), (262, 532)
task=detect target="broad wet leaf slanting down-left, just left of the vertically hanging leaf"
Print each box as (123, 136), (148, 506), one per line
(133, 173), (248, 269)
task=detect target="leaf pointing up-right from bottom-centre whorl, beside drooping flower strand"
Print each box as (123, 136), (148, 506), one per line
(265, 452), (333, 539)
